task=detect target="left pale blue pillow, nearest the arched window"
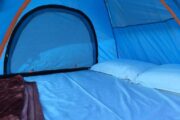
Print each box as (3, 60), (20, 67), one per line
(91, 59), (157, 81)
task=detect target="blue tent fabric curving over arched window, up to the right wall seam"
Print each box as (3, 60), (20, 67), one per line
(17, 0), (117, 62)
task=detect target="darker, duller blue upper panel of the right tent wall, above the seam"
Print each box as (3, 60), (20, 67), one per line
(106, 0), (172, 27)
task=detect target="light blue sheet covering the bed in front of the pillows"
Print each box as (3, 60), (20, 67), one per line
(25, 70), (180, 120)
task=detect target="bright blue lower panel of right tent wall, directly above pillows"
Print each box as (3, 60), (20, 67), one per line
(114, 20), (180, 64)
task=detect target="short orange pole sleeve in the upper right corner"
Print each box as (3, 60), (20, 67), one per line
(160, 0), (180, 25)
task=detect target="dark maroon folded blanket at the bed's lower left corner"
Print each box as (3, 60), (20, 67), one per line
(0, 76), (44, 120)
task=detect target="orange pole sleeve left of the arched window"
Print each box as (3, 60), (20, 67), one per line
(0, 0), (31, 58)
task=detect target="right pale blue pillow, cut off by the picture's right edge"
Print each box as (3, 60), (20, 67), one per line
(136, 64), (180, 93)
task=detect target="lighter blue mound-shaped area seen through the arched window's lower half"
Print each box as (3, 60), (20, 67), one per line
(17, 44), (94, 73)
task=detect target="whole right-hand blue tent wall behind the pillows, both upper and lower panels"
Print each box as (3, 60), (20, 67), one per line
(106, 0), (180, 64)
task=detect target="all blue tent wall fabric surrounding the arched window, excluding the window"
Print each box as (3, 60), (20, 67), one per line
(0, 0), (180, 74)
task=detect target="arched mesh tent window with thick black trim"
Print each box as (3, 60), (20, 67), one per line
(4, 5), (97, 74)
